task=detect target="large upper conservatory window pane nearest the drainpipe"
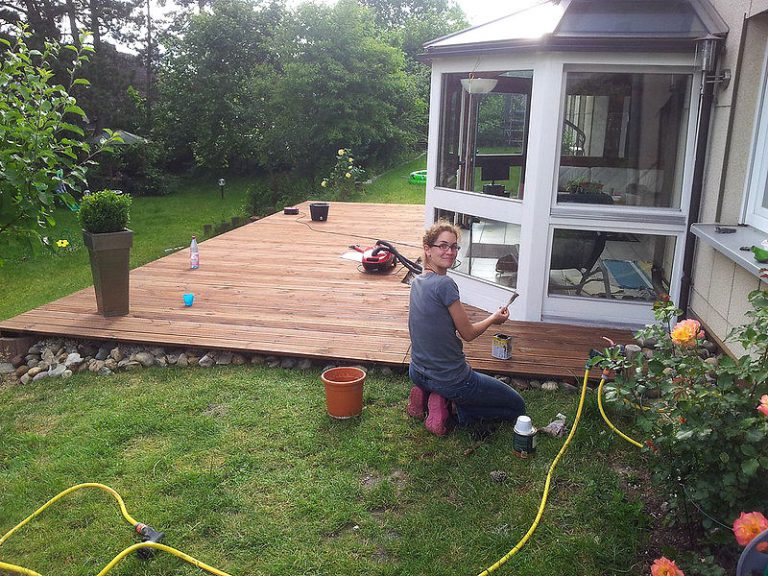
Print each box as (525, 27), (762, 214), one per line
(557, 72), (691, 208)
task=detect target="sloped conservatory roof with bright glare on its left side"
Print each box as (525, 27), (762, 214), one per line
(424, 0), (728, 59)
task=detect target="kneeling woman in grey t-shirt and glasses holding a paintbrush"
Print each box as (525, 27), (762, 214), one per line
(408, 221), (525, 436)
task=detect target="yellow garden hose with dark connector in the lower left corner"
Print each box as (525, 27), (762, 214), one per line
(0, 482), (230, 576)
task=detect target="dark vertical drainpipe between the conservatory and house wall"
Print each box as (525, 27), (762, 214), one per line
(678, 36), (722, 314)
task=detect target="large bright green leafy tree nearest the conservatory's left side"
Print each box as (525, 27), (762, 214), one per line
(270, 0), (417, 176)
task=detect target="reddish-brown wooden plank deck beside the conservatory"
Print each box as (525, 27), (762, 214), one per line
(0, 203), (630, 376)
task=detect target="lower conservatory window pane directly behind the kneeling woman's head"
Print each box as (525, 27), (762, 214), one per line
(435, 209), (520, 288)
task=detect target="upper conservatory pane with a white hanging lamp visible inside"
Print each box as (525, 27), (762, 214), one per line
(437, 70), (533, 198)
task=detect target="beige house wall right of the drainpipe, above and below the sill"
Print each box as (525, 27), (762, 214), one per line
(689, 0), (768, 355)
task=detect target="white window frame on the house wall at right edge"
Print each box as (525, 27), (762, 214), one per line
(742, 41), (768, 232)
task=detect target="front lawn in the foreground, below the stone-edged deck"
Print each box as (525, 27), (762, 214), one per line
(0, 366), (647, 576)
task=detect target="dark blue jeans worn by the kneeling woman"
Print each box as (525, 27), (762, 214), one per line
(408, 365), (525, 426)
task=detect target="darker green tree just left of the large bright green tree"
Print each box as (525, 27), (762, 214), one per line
(155, 0), (284, 170)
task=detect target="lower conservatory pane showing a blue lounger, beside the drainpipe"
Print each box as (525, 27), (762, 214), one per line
(547, 229), (675, 302)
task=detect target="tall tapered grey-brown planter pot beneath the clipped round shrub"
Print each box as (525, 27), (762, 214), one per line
(83, 229), (133, 316)
